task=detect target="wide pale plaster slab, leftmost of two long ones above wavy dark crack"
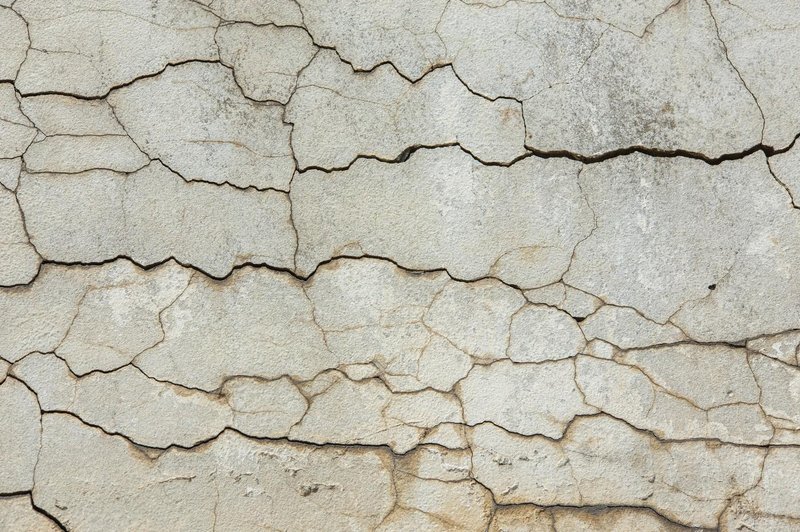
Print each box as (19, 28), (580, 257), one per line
(17, 162), (295, 277)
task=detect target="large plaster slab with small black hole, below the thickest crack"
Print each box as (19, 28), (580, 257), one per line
(564, 154), (800, 332)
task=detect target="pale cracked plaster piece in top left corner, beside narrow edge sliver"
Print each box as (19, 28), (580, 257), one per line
(14, 0), (219, 97)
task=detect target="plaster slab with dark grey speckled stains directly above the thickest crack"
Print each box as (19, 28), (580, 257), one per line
(524, 0), (763, 158)
